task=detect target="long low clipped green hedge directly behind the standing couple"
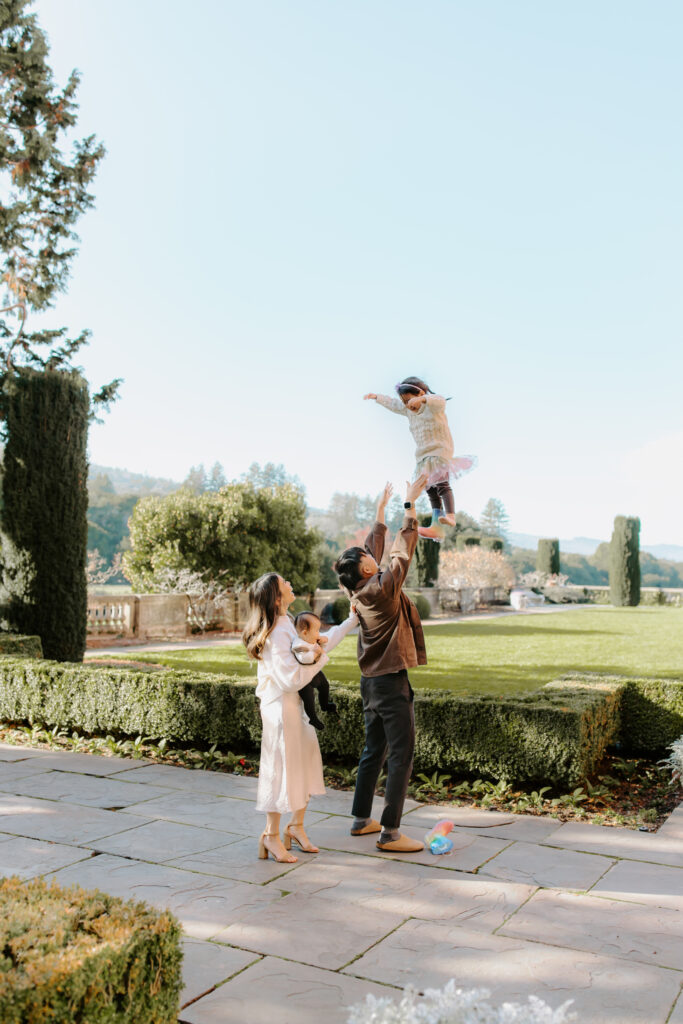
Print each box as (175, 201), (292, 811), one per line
(0, 658), (643, 785)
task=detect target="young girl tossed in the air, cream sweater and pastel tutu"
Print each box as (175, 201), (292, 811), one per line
(364, 377), (476, 541)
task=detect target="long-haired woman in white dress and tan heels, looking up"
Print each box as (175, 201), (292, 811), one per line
(242, 572), (357, 863)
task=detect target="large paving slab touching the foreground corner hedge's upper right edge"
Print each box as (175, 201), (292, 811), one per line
(50, 854), (283, 939)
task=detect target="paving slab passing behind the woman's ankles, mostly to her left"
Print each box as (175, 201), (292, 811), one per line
(120, 791), (326, 836)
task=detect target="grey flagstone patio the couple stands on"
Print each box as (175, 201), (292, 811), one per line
(0, 744), (683, 1024)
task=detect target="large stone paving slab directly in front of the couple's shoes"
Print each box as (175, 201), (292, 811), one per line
(266, 853), (535, 932)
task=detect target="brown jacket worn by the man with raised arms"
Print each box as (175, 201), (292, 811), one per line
(352, 516), (427, 677)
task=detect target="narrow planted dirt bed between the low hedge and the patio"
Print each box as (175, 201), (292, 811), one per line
(0, 723), (683, 831)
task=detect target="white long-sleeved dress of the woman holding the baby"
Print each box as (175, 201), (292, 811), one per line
(256, 615), (358, 814)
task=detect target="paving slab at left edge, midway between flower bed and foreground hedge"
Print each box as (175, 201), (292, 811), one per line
(0, 794), (150, 846)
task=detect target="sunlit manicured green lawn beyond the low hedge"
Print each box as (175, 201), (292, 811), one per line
(101, 607), (683, 693)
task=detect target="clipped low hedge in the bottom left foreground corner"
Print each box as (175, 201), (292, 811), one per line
(0, 878), (182, 1024)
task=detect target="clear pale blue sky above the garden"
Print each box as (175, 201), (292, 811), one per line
(35, 0), (683, 544)
